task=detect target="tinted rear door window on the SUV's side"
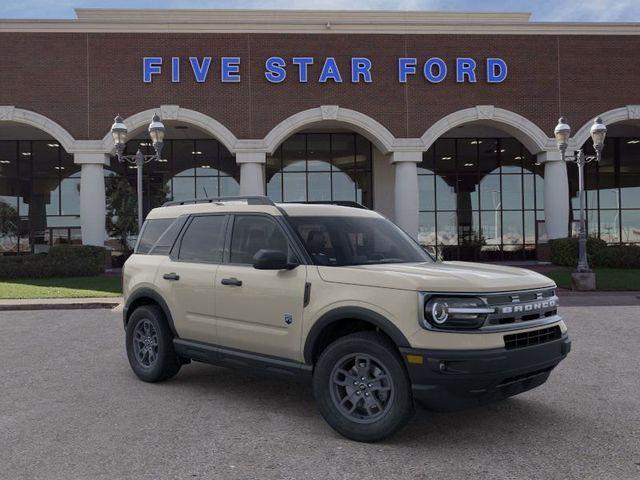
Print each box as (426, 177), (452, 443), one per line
(178, 215), (227, 263)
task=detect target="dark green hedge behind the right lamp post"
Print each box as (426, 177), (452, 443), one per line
(549, 237), (640, 268)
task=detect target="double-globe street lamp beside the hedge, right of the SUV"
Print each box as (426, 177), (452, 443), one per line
(554, 117), (607, 273)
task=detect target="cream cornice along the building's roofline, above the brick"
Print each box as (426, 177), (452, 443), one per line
(0, 8), (640, 35)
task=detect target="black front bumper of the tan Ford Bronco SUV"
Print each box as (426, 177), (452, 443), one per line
(400, 334), (571, 411)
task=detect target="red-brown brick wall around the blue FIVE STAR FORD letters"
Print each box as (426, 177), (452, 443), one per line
(0, 33), (640, 139)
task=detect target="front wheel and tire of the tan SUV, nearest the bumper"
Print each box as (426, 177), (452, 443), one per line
(313, 332), (414, 442)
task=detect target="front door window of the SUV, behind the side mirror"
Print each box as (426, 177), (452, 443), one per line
(229, 215), (289, 264)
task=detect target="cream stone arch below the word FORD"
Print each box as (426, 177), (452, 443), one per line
(421, 105), (555, 154)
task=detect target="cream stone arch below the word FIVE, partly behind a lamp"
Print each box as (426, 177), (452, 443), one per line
(102, 105), (238, 155)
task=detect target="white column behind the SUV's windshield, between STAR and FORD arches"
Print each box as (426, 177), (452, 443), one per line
(391, 152), (422, 239)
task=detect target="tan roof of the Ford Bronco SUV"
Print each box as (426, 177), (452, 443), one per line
(147, 201), (380, 219)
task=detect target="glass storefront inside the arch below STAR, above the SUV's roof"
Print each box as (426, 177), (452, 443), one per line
(265, 133), (373, 208)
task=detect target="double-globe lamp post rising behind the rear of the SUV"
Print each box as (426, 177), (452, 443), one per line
(111, 114), (165, 234)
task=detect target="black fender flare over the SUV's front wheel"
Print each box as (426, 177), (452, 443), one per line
(303, 307), (411, 365)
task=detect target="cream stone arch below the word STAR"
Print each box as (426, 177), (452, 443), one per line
(263, 105), (395, 154)
